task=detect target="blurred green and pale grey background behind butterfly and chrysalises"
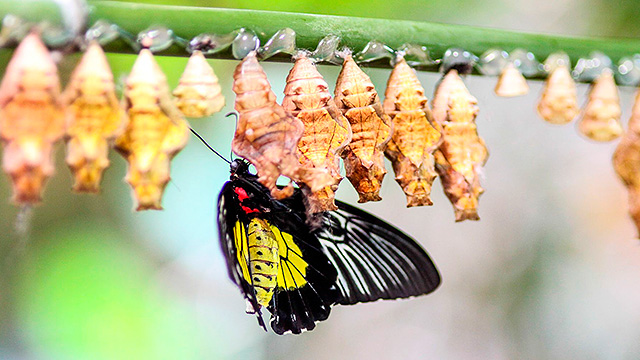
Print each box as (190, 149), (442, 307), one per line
(0, 0), (640, 359)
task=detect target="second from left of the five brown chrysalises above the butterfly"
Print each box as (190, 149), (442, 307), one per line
(282, 54), (351, 213)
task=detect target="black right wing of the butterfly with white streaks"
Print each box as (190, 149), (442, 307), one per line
(315, 201), (440, 305)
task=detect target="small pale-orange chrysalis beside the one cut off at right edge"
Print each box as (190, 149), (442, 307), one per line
(578, 70), (622, 141)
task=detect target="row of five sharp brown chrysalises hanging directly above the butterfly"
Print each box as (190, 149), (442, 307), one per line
(232, 52), (488, 221)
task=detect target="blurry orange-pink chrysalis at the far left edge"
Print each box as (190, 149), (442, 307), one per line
(0, 33), (64, 204)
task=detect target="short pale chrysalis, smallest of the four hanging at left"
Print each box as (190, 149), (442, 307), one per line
(173, 50), (224, 118)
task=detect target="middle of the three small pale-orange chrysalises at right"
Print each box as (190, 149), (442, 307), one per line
(538, 65), (580, 124)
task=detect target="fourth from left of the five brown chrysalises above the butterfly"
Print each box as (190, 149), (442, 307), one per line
(384, 59), (442, 207)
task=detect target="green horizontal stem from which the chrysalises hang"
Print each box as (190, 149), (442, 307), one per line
(0, 0), (640, 74)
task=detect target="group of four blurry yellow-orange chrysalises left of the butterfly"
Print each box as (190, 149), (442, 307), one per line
(0, 33), (224, 210)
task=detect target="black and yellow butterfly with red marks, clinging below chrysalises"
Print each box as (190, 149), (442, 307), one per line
(218, 159), (440, 335)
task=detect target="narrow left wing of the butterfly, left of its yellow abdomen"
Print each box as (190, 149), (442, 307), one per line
(218, 181), (267, 330)
